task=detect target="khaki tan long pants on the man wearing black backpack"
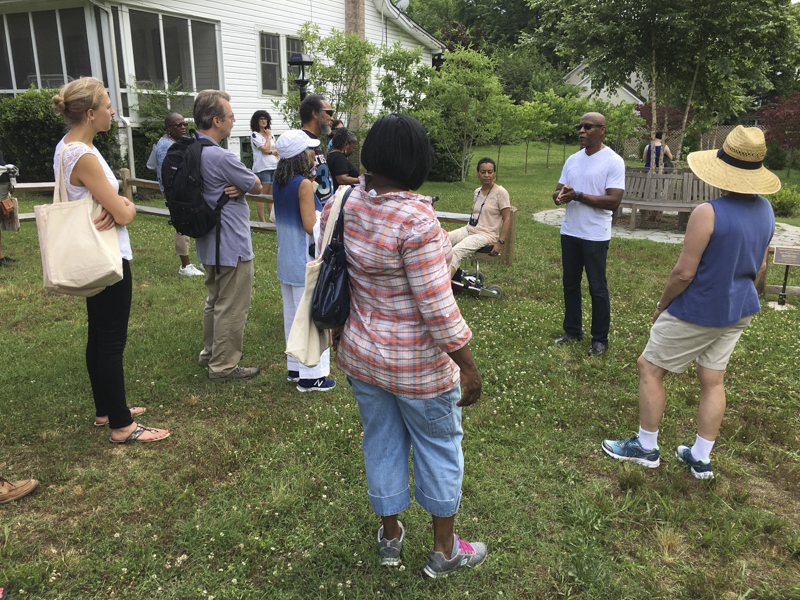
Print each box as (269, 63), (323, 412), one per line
(200, 260), (254, 376)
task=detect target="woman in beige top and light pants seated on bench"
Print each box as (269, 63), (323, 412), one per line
(448, 158), (511, 279)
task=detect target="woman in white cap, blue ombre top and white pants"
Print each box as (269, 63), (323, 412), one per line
(272, 129), (336, 392)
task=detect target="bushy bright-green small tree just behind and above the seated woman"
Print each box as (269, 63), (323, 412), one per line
(412, 48), (502, 183)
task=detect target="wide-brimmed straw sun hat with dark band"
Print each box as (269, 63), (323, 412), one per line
(688, 125), (781, 194)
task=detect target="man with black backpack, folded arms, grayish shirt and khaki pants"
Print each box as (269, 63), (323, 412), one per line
(184, 90), (261, 381)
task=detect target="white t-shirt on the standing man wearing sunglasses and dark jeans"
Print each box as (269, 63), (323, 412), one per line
(558, 146), (625, 242)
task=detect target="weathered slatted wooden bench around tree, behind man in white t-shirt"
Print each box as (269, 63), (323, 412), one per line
(614, 167), (720, 231)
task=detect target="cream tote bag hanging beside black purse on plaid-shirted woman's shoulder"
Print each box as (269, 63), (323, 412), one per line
(286, 185), (349, 367)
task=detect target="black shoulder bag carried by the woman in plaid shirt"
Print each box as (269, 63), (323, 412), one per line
(311, 188), (353, 329)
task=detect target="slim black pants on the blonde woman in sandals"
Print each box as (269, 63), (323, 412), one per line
(86, 258), (133, 429)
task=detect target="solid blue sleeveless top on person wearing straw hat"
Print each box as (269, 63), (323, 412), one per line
(667, 196), (775, 327)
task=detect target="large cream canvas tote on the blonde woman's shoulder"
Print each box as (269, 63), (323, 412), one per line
(33, 142), (122, 297)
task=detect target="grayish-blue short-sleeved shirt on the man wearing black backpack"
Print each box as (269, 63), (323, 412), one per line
(196, 132), (257, 267)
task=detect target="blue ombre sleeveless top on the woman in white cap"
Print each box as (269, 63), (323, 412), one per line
(272, 175), (322, 287)
